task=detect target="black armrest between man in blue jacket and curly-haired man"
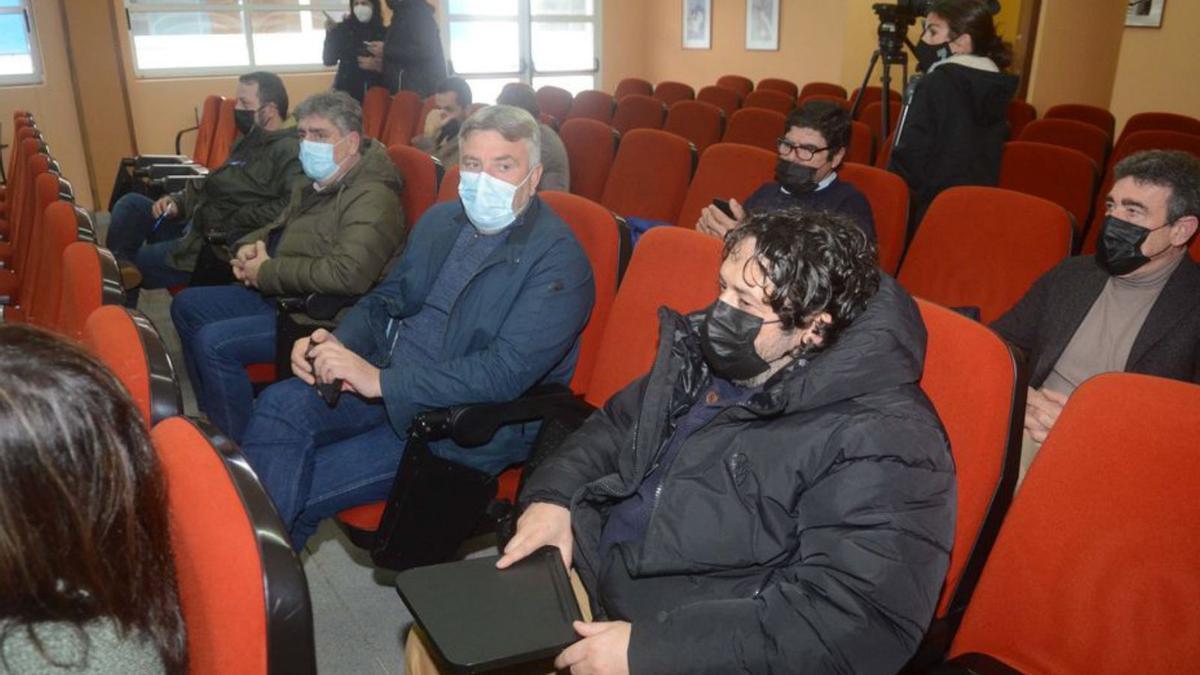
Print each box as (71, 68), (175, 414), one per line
(413, 384), (590, 448)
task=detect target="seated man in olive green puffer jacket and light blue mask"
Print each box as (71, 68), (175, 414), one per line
(170, 90), (404, 441)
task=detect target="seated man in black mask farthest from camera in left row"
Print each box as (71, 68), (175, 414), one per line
(107, 72), (304, 305)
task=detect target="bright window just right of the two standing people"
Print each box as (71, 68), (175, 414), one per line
(443, 0), (600, 103)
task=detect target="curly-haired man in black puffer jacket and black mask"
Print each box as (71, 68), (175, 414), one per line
(470, 209), (955, 675)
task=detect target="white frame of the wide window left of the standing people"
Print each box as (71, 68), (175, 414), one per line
(123, 0), (346, 79)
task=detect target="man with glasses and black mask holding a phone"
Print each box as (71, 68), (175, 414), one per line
(696, 101), (875, 243)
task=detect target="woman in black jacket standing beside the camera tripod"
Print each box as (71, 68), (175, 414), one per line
(888, 0), (1018, 237)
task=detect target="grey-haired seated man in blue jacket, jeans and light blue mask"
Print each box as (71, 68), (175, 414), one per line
(242, 106), (595, 550)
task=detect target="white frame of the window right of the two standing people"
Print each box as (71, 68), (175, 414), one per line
(438, 0), (604, 98)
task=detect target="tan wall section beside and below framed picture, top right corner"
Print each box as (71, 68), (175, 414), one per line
(1109, 0), (1200, 129)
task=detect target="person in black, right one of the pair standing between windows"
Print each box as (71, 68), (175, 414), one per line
(367, 0), (446, 97)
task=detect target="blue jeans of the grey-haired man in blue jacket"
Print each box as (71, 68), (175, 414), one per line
(241, 378), (404, 550)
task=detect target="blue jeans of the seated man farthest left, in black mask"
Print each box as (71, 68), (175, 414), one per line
(104, 192), (192, 307)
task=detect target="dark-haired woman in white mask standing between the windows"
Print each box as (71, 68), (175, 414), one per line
(324, 0), (384, 103)
